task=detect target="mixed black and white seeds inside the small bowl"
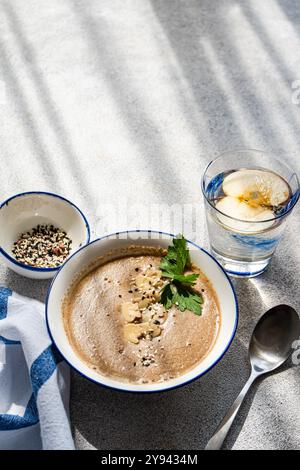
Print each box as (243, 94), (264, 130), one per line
(12, 224), (72, 268)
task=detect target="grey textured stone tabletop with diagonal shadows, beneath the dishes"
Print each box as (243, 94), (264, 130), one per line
(0, 0), (300, 449)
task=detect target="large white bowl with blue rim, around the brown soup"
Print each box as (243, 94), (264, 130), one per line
(46, 230), (238, 393)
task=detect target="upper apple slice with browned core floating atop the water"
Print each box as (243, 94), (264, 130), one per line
(223, 169), (290, 207)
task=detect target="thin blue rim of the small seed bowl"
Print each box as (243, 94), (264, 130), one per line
(0, 191), (91, 273)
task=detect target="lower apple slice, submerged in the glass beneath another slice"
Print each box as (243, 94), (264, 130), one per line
(216, 196), (275, 232)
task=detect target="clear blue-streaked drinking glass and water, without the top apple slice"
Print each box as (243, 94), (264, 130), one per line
(201, 150), (299, 277)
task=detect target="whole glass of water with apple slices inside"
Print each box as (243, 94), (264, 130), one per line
(202, 150), (299, 277)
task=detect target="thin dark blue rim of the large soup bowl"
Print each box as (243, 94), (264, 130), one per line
(45, 229), (239, 394)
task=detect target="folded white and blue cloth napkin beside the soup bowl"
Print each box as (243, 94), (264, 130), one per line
(0, 287), (74, 450)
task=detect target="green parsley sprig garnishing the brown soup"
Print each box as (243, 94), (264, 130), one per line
(160, 235), (203, 315)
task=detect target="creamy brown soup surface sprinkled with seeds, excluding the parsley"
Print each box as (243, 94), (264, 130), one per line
(62, 246), (221, 384)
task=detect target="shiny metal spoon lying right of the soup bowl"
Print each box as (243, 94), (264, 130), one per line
(206, 305), (300, 450)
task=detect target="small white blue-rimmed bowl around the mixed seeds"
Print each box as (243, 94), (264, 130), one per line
(0, 191), (90, 279)
